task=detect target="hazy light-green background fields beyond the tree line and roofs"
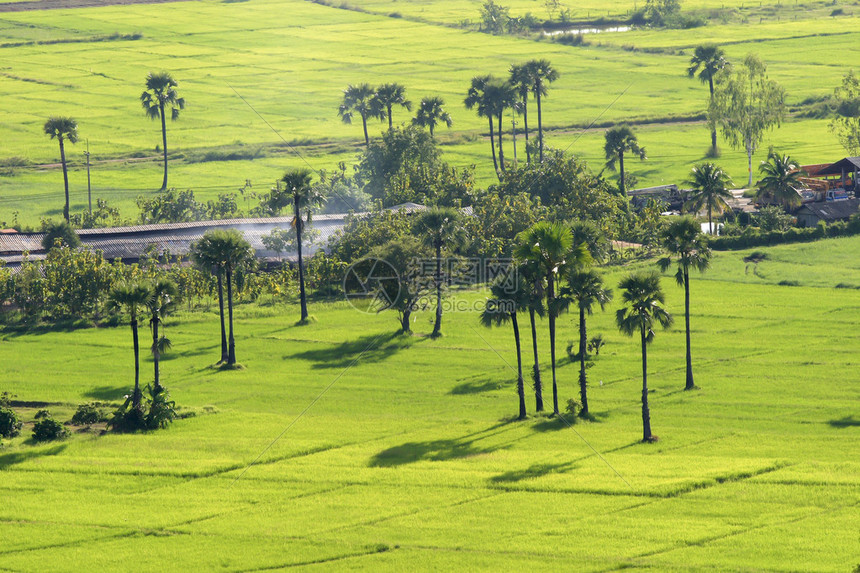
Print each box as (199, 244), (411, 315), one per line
(0, 0), (860, 225)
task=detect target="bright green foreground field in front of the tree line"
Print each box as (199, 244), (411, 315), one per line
(0, 238), (860, 571)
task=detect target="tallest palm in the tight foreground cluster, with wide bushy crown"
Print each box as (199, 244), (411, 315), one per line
(515, 221), (590, 414)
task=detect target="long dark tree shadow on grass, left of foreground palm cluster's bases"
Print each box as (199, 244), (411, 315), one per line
(368, 422), (522, 467)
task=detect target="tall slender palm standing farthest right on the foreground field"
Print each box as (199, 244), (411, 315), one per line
(658, 217), (711, 390)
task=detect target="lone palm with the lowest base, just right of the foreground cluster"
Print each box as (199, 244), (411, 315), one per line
(615, 272), (672, 442)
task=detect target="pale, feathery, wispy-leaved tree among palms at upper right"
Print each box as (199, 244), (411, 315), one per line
(709, 54), (786, 187)
